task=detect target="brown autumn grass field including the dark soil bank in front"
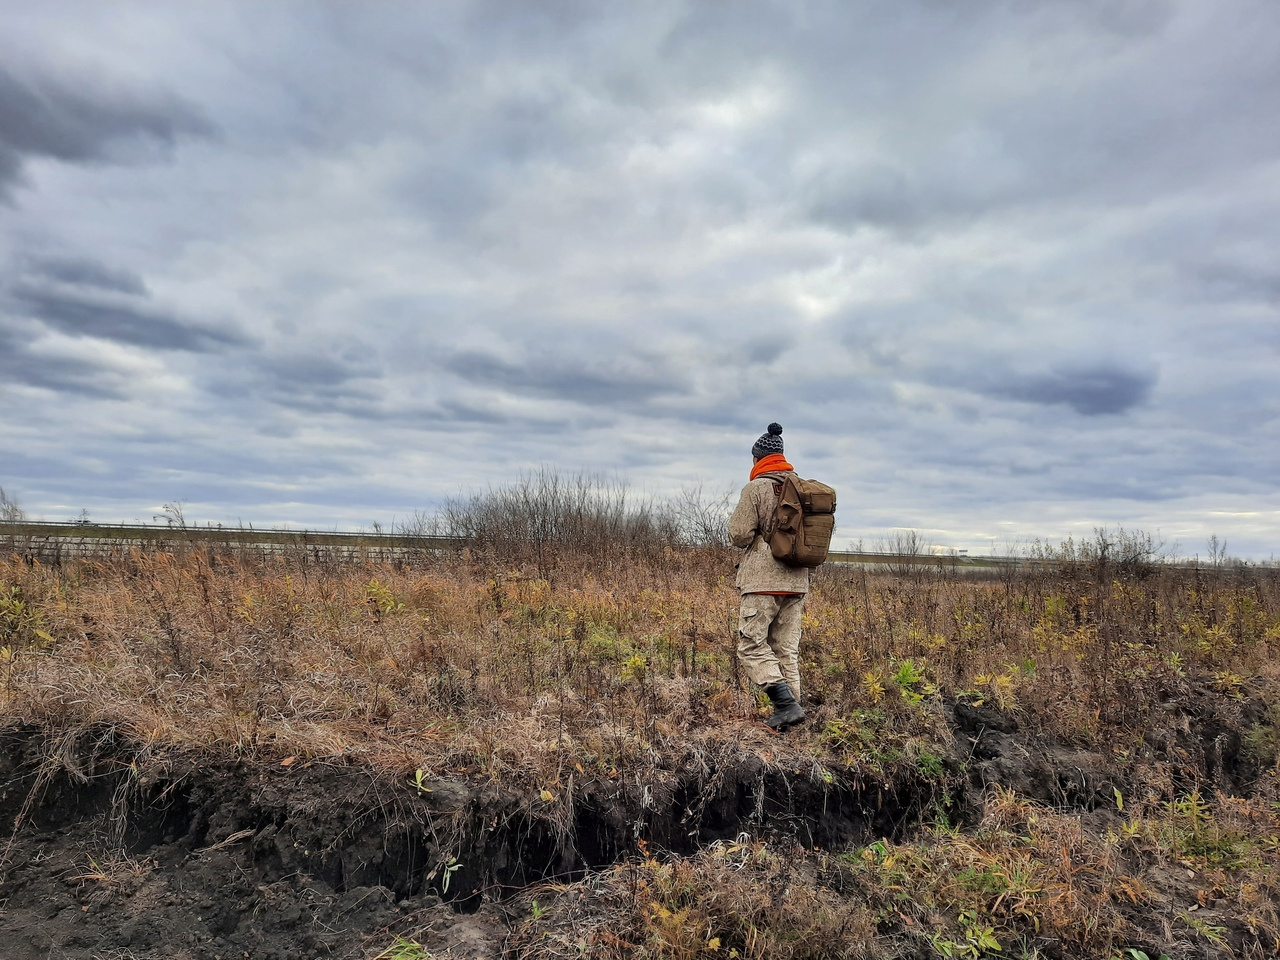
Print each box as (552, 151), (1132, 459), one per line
(0, 522), (1280, 960)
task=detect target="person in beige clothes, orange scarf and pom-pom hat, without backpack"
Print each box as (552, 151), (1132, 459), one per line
(728, 424), (809, 731)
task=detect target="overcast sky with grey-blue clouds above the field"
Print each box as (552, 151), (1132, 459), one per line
(0, 0), (1280, 558)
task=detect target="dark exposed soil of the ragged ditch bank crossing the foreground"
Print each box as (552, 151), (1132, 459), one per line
(0, 686), (1269, 960)
